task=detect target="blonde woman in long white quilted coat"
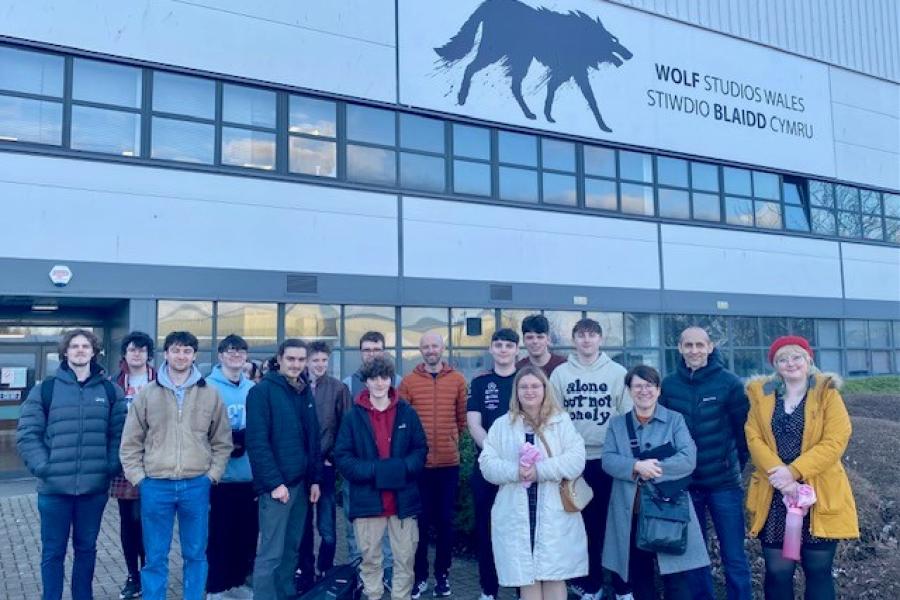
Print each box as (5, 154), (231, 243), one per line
(478, 365), (588, 600)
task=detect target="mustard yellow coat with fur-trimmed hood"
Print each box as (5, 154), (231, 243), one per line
(744, 373), (859, 539)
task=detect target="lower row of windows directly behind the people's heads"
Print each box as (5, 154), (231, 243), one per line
(157, 300), (900, 377)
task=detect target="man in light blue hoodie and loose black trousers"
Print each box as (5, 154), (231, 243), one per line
(206, 334), (259, 600)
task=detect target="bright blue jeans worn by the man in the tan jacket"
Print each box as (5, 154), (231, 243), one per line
(140, 475), (212, 600)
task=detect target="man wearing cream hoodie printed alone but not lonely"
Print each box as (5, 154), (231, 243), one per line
(550, 319), (633, 600)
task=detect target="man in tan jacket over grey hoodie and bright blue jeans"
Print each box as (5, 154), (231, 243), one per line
(119, 331), (232, 600)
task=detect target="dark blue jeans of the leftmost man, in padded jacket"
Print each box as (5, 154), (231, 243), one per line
(38, 491), (107, 600)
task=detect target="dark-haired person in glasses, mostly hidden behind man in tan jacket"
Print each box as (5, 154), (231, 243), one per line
(109, 331), (156, 600)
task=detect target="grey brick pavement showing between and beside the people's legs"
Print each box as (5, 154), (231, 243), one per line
(0, 480), (515, 600)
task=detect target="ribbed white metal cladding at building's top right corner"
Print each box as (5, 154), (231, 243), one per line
(608, 0), (900, 81)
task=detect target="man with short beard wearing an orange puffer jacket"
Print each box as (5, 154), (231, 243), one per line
(398, 331), (467, 599)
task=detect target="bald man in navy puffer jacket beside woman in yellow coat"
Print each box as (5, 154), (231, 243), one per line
(659, 327), (752, 600)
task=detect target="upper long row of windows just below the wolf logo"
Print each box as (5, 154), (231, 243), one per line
(0, 46), (900, 243)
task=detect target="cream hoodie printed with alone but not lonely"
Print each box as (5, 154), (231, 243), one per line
(550, 352), (634, 460)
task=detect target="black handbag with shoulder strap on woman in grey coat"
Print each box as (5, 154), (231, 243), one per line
(625, 415), (691, 555)
